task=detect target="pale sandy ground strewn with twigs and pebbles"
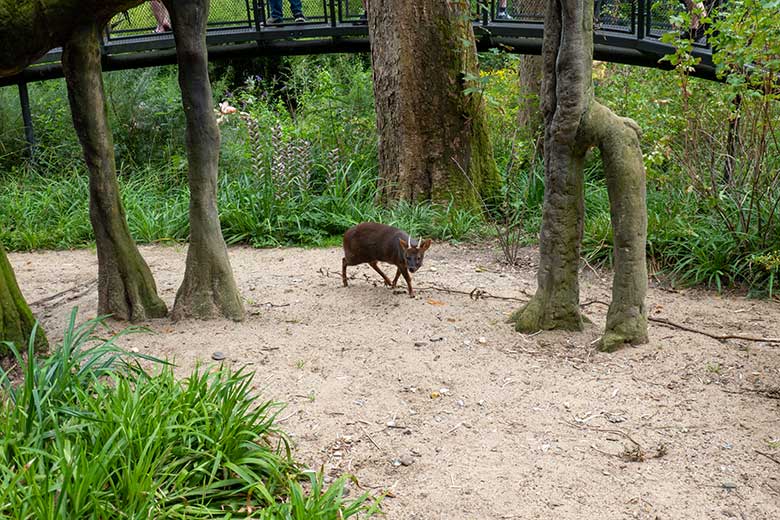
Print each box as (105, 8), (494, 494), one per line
(10, 244), (780, 520)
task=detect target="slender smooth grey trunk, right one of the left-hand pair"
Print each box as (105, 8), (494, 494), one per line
(165, 0), (244, 321)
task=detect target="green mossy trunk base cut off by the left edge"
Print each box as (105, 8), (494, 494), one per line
(0, 245), (47, 358)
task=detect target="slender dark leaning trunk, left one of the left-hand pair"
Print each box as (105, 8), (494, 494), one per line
(62, 23), (168, 321)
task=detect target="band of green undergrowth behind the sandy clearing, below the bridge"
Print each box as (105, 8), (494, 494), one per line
(0, 41), (780, 294)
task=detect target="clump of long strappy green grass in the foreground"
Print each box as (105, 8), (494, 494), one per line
(0, 310), (378, 520)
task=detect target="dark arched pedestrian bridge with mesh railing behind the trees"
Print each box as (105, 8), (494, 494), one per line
(0, 0), (715, 86)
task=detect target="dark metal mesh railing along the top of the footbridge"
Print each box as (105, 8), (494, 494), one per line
(94, 0), (719, 56)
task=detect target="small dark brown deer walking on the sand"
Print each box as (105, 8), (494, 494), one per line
(341, 222), (431, 298)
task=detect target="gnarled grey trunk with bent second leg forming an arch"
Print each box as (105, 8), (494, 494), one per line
(512, 0), (647, 351)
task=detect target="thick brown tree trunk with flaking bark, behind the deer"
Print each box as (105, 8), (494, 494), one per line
(368, 0), (500, 208)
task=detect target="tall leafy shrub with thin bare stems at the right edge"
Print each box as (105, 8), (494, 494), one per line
(664, 0), (780, 294)
